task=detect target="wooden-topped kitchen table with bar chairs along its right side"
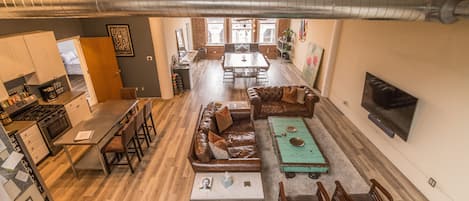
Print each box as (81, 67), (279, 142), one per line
(54, 99), (138, 177)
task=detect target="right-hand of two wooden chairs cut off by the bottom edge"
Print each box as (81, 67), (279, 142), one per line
(332, 179), (394, 201)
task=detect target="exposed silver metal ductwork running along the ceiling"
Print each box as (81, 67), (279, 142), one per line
(0, 0), (469, 23)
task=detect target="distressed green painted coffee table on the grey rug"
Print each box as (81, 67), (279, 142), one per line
(268, 117), (329, 179)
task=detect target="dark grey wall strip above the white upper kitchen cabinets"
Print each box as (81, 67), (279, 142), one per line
(0, 19), (83, 40)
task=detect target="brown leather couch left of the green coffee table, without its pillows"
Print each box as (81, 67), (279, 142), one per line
(188, 103), (261, 172)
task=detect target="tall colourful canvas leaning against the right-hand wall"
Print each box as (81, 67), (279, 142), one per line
(303, 43), (324, 87)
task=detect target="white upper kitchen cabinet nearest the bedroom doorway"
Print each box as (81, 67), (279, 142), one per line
(24, 31), (66, 85)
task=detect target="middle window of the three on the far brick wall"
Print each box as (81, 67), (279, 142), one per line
(231, 18), (252, 43)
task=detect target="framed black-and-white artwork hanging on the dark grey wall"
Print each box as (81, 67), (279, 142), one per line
(106, 24), (135, 57)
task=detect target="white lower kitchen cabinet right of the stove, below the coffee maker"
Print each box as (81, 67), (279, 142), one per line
(65, 94), (91, 127)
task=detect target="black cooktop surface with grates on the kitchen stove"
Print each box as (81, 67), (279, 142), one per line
(12, 105), (63, 121)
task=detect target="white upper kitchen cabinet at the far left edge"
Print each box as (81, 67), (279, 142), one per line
(0, 35), (34, 82)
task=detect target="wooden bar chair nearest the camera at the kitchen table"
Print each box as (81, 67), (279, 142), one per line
(102, 118), (142, 174)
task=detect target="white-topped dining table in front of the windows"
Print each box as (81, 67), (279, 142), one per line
(223, 52), (269, 78)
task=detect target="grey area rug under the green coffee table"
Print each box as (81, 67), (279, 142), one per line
(254, 117), (369, 201)
